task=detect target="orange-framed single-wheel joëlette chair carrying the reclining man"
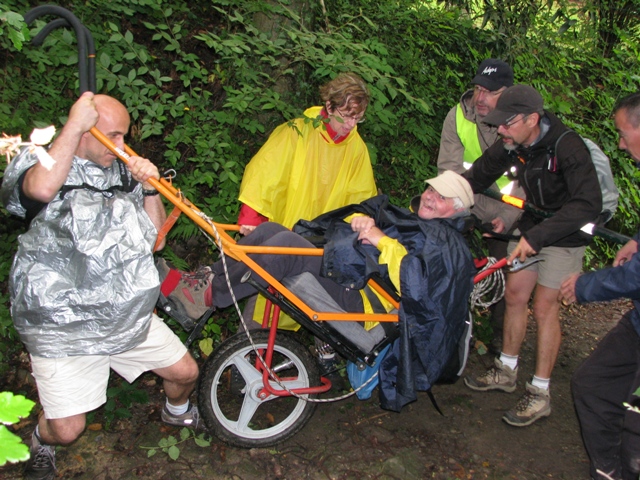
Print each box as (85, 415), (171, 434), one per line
(18, 5), (536, 447)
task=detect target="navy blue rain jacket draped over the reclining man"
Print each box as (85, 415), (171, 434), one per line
(294, 195), (476, 411)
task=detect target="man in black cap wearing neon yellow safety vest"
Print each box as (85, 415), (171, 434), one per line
(438, 58), (524, 352)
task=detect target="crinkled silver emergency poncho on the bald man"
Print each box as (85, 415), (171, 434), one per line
(0, 149), (160, 357)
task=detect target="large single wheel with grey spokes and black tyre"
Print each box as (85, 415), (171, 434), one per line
(198, 330), (320, 448)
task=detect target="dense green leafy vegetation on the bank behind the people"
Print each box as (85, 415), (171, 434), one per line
(0, 0), (640, 350)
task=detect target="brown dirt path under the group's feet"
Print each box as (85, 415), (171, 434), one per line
(0, 302), (630, 480)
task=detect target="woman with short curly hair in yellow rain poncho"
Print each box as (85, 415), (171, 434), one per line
(238, 73), (377, 330)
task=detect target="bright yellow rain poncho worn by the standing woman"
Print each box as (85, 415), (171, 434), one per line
(239, 107), (377, 330)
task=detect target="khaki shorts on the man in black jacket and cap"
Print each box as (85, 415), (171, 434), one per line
(507, 241), (587, 290)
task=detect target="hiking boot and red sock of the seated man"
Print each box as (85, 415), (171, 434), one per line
(156, 258), (213, 322)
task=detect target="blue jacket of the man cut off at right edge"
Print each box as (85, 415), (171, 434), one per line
(576, 231), (640, 335)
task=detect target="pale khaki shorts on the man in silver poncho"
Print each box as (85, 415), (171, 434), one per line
(31, 314), (187, 419)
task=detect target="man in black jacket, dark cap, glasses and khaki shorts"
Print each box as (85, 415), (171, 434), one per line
(463, 85), (602, 427)
